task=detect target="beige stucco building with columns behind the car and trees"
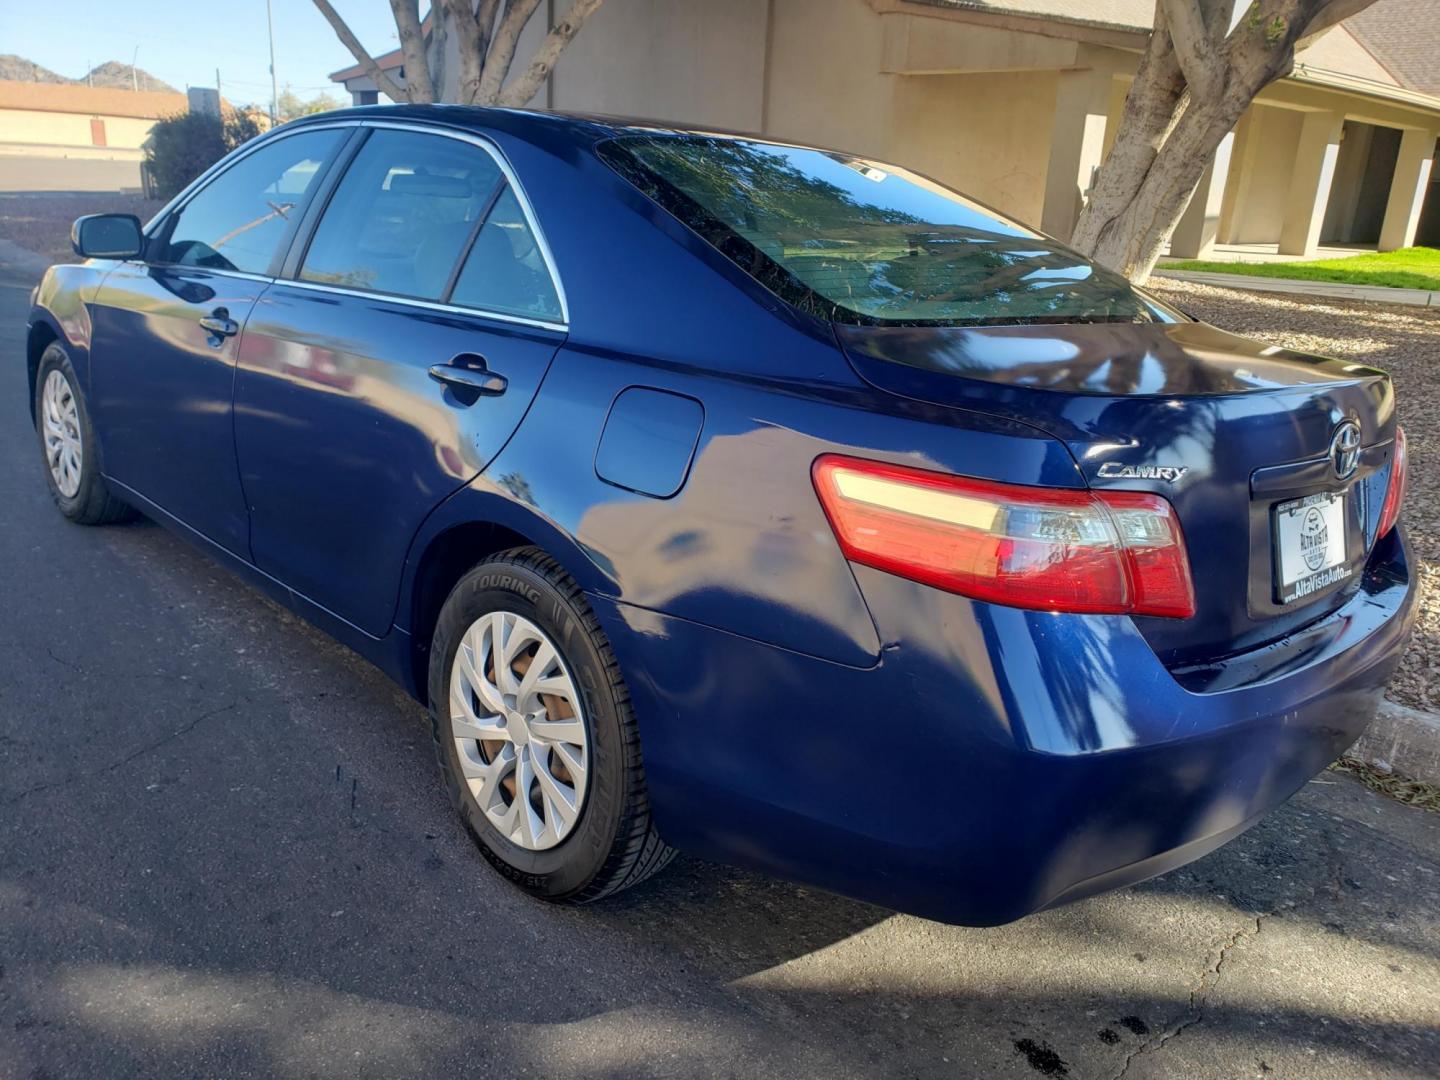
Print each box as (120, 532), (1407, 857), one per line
(333, 0), (1440, 256)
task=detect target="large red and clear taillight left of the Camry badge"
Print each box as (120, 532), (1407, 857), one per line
(814, 455), (1195, 618)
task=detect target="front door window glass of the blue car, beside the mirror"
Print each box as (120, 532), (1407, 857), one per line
(156, 128), (346, 274)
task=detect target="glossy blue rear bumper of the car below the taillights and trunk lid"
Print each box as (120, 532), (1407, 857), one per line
(595, 534), (1414, 924)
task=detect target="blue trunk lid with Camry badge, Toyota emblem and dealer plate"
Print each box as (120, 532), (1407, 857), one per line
(835, 323), (1394, 664)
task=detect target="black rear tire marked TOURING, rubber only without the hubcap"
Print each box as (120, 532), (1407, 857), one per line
(429, 547), (675, 904)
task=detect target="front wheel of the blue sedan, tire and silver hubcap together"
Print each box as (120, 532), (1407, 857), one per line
(35, 341), (134, 526)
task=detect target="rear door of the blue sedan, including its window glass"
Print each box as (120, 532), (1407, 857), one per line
(235, 125), (566, 636)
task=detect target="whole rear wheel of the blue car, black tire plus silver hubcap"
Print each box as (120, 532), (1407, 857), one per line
(429, 547), (674, 903)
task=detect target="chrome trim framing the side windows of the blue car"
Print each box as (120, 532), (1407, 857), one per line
(144, 118), (570, 333)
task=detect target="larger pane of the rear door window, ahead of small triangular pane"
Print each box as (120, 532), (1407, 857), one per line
(300, 128), (504, 301)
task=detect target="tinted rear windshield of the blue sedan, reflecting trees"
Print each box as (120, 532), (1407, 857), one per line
(599, 134), (1172, 325)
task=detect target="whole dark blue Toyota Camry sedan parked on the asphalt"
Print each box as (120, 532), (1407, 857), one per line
(27, 107), (1414, 924)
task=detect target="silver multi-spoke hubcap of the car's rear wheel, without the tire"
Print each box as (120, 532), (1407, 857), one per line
(449, 611), (590, 851)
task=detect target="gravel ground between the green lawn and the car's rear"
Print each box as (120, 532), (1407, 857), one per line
(1152, 279), (1440, 710)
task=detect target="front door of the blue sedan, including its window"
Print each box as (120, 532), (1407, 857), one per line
(89, 128), (350, 557)
